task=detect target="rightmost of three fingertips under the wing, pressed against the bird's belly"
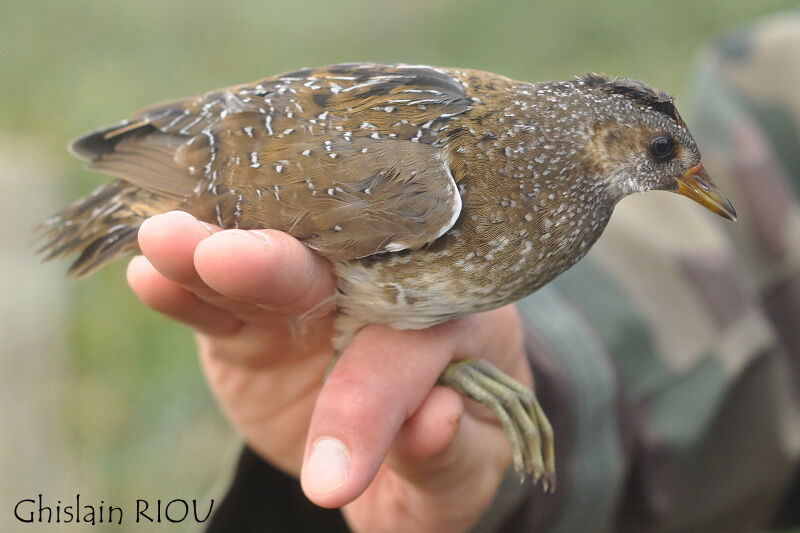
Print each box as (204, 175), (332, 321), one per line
(194, 230), (336, 313)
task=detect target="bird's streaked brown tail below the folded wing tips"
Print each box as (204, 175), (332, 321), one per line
(36, 179), (177, 278)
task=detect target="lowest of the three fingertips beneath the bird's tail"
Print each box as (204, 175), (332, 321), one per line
(127, 256), (242, 336)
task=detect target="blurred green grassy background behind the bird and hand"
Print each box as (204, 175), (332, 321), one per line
(0, 0), (795, 531)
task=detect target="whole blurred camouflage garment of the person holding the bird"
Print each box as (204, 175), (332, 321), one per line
(498, 9), (800, 532)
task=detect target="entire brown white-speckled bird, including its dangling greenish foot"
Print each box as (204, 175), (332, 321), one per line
(38, 63), (736, 491)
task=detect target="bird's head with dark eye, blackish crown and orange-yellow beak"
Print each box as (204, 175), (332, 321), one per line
(579, 74), (736, 220)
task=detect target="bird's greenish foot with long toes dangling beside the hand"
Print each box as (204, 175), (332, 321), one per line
(439, 359), (556, 492)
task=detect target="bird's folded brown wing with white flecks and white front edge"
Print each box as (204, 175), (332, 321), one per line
(72, 64), (472, 260)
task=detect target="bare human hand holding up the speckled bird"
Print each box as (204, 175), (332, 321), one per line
(128, 212), (532, 531)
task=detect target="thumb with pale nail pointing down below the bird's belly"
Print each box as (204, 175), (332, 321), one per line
(300, 326), (452, 507)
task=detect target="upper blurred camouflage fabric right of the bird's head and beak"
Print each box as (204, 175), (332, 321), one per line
(692, 11), (800, 360)
